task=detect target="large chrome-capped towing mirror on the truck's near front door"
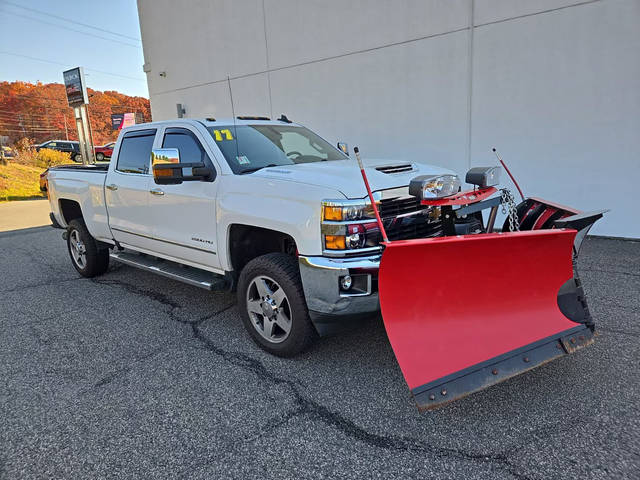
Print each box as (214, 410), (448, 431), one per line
(151, 148), (213, 185)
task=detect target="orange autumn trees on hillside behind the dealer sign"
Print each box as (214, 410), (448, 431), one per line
(0, 82), (151, 145)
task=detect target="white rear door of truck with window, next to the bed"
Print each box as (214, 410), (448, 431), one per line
(105, 129), (156, 249)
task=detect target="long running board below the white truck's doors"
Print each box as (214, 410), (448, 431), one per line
(109, 251), (228, 290)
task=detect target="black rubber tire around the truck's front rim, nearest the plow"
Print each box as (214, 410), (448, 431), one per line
(238, 253), (317, 357)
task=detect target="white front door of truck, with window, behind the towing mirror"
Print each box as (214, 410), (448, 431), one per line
(148, 126), (220, 271)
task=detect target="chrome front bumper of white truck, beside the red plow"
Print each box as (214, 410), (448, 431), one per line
(299, 253), (381, 335)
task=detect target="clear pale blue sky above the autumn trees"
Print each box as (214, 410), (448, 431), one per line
(0, 0), (149, 98)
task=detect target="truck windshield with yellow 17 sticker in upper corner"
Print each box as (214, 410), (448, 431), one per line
(208, 125), (348, 174)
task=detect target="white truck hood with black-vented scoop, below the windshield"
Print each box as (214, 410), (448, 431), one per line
(251, 159), (455, 198)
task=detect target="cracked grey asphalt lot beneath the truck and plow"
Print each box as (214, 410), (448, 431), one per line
(0, 227), (640, 479)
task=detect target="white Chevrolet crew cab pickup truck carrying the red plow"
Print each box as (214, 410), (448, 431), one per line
(49, 116), (462, 356)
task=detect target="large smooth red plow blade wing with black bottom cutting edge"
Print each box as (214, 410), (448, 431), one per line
(379, 229), (601, 410)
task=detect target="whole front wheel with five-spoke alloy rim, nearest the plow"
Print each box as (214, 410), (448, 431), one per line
(238, 253), (316, 357)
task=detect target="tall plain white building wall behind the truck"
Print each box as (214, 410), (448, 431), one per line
(138, 0), (640, 238)
